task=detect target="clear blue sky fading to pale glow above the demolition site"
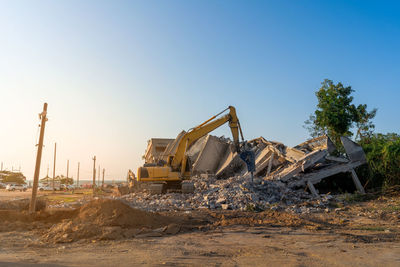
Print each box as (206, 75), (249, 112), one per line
(0, 0), (400, 182)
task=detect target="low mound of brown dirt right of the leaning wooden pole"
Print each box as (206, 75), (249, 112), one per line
(42, 199), (176, 243)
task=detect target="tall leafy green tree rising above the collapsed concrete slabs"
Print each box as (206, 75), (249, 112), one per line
(304, 79), (377, 148)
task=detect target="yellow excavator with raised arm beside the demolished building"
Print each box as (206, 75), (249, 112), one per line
(129, 106), (254, 194)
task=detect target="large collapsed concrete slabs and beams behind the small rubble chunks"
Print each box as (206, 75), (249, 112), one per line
(182, 136), (366, 199)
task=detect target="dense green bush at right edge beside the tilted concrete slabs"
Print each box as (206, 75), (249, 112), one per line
(361, 133), (400, 189)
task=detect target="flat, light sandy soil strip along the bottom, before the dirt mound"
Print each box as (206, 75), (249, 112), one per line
(0, 226), (400, 266)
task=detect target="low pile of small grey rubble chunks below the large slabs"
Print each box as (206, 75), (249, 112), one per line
(118, 175), (330, 215)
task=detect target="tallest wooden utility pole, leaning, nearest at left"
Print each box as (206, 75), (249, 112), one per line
(29, 103), (47, 213)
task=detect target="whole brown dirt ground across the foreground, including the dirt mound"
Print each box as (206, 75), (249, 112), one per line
(0, 192), (400, 266)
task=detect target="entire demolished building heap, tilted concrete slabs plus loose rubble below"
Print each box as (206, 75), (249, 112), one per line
(126, 136), (366, 213)
